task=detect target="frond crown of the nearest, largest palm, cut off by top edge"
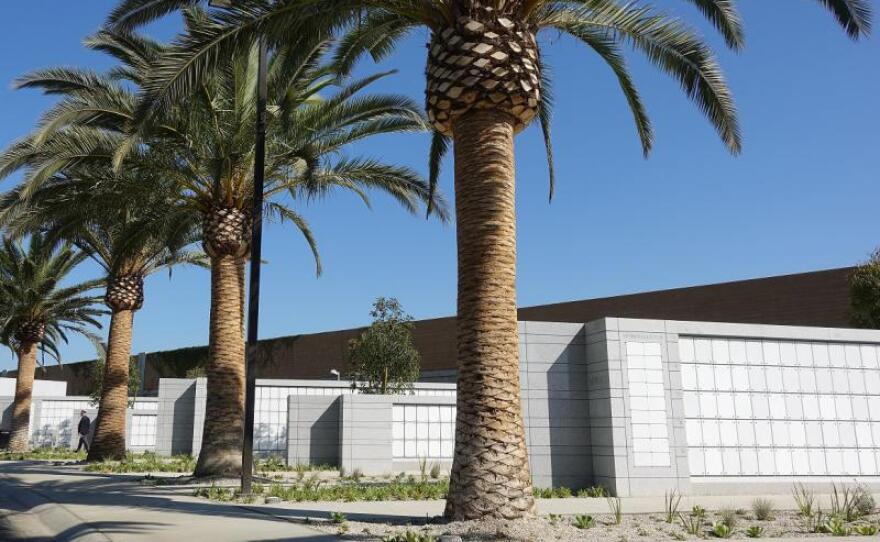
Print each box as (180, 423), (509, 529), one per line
(109, 0), (871, 200)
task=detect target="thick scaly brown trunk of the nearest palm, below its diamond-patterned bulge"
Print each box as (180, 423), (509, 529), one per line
(446, 110), (534, 520)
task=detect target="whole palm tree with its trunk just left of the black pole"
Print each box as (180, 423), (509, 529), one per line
(0, 22), (446, 475)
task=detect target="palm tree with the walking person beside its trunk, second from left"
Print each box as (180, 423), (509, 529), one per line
(0, 155), (200, 461)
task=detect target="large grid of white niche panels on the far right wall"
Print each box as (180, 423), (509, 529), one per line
(679, 337), (880, 476)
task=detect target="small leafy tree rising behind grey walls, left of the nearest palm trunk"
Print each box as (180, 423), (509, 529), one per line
(348, 297), (421, 394)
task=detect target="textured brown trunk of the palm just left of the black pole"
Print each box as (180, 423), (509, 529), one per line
(195, 255), (245, 476)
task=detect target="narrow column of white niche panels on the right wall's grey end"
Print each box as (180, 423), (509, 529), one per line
(626, 342), (670, 467)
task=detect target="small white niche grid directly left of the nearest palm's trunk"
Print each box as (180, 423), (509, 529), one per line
(391, 405), (455, 459)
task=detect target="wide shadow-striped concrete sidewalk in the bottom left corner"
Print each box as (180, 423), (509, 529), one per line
(0, 463), (338, 542)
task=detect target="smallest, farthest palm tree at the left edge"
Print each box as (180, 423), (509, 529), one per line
(0, 234), (103, 452)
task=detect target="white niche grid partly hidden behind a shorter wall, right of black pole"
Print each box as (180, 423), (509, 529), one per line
(254, 386), (455, 456)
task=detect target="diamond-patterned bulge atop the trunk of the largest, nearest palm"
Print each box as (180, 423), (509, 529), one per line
(427, 2), (541, 136)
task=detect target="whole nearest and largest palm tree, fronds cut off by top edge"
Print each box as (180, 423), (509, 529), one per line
(110, 0), (869, 519)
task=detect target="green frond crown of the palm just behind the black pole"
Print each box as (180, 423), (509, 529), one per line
(0, 21), (446, 272)
